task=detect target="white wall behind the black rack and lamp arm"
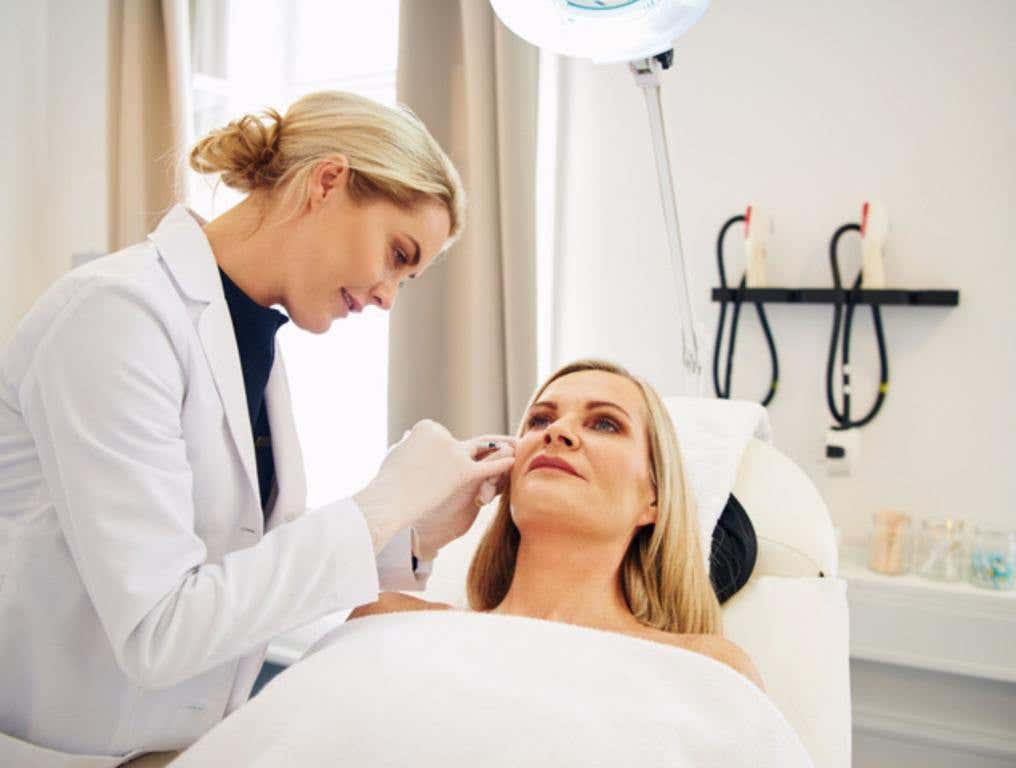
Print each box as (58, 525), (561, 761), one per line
(553, 0), (1016, 541)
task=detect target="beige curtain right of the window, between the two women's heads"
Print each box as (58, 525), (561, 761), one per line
(388, 0), (538, 441)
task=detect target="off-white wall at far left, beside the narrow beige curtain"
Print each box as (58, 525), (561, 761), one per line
(0, 0), (109, 339)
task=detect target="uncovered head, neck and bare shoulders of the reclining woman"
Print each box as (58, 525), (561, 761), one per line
(350, 361), (764, 690)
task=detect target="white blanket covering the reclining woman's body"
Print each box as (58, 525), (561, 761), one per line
(172, 612), (811, 768)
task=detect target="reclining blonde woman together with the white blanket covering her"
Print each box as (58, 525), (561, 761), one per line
(168, 363), (800, 768)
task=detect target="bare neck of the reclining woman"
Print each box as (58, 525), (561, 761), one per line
(494, 531), (641, 631)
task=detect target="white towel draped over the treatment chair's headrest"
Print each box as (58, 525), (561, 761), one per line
(663, 397), (772, 568)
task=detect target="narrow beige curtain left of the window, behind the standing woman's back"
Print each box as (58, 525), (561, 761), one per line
(109, 0), (191, 250)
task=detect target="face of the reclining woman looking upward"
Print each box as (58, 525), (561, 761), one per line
(511, 371), (656, 545)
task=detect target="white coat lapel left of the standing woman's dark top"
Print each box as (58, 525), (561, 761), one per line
(148, 205), (263, 516)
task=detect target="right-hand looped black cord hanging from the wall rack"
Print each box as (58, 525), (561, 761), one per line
(826, 223), (889, 430)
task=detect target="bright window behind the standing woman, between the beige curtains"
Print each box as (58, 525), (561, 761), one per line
(187, 0), (398, 507)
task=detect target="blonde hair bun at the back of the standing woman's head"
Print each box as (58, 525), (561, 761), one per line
(190, 109), (282, 192)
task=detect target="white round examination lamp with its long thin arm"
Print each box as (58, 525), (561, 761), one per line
(491, 0), (709, 384)
